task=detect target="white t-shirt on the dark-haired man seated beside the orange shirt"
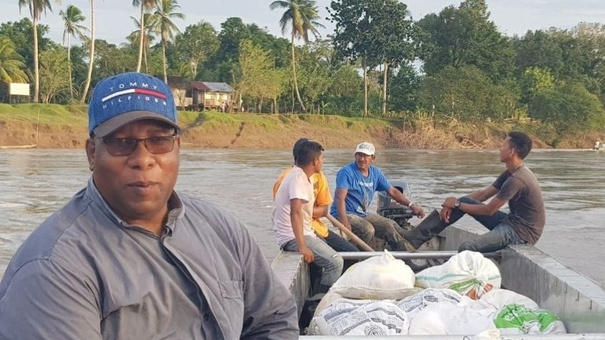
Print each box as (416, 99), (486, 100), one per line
(271, 166), (316, 247)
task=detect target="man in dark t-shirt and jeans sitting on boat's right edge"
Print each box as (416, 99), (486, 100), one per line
(404, 131), (546, 252)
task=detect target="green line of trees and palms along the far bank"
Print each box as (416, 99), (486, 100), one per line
(0, 0), (605, 142)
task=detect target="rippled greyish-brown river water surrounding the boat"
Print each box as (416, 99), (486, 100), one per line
(0, 149), (605, 287)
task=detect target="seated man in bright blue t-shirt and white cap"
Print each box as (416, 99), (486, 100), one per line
(330, 142), (424, 250)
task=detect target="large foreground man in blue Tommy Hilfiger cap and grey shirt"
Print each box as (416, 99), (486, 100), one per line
(0, 73), (298, 339)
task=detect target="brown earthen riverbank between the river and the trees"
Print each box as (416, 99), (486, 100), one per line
(0, 104), (598, 150)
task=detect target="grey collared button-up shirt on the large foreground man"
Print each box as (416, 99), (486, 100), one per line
(0, 179), (298, 340)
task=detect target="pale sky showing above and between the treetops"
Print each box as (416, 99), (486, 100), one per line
(0, 0), (605, 44)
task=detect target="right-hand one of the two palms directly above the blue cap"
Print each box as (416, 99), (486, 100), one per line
(149, 0), (185, 83)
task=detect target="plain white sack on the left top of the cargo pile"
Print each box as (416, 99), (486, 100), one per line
(330, 250), (419, 300)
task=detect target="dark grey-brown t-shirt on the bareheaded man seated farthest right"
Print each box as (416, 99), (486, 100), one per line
(492, 165), (546, 244)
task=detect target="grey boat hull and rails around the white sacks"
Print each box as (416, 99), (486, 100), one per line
(272, 226), (605, 339)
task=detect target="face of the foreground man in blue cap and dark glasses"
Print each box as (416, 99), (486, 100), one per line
(86, 120), (181, 224)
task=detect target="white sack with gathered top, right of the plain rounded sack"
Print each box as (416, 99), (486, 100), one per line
(416, 250), (502, 300)
